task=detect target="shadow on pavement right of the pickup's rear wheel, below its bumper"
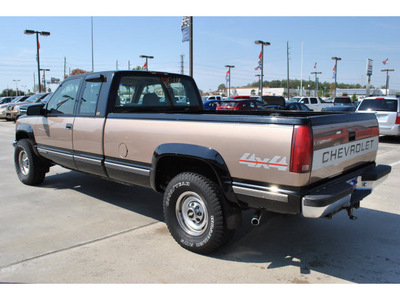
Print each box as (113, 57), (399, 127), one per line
(213, 208), (400, 283)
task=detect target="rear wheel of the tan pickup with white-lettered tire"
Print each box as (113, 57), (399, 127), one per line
(163, 173), (233, 254)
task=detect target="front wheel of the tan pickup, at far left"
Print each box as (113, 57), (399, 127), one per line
(14, 139), (46, 185)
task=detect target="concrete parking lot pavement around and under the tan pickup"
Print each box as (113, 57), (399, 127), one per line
(0, 120), (400, 283)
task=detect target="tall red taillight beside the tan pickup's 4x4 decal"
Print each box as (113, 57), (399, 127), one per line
(290, 125), (313, 173)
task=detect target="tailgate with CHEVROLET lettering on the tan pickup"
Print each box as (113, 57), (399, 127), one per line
(310, 114), (379, 183)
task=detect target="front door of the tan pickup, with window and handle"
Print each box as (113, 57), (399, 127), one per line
(35, 78), (82, 169)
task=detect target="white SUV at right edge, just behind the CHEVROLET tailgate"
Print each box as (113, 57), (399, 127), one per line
(357, 97), (400, 136)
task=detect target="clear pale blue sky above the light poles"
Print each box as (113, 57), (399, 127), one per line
(0, 0), (400, 92)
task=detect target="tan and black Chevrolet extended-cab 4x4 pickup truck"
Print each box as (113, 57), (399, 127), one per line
(13, 71), (391, 254)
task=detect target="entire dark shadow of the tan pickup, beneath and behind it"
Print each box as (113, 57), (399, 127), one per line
(41, 171), (400, 283)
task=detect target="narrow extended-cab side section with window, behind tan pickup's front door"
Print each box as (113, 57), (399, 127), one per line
(72, 75), (106, 176)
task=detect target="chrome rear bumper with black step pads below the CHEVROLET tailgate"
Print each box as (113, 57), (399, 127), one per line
(302, 165), (391, 218)
